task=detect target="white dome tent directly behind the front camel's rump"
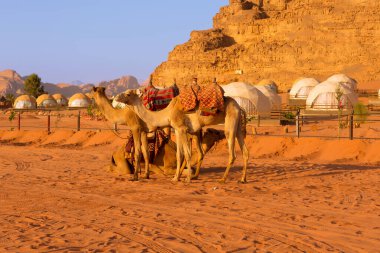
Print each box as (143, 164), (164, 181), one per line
(222, 82), (271, 116)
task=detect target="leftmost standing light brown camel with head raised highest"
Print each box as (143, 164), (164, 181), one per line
(92, 87), (149, 180)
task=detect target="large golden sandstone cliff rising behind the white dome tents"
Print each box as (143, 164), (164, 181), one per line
(153, 0), (380, 90)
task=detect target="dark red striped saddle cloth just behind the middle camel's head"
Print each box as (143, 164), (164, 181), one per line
(141, 85), (179, 111)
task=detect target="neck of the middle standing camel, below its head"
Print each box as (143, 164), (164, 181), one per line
(133, 100), (174, 128)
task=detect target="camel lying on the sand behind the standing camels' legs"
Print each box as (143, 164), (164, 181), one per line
(109, 128), (225, 175)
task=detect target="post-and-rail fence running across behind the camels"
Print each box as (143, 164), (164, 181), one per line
(0, 109), (380, 140)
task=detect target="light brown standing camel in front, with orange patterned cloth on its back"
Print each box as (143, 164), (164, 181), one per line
(117, 90), (249, 183)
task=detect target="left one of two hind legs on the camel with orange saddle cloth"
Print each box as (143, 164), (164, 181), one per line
(219, 117), (238, 183)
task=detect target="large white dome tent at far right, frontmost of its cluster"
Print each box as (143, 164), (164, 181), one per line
(306, 81), (358, 110)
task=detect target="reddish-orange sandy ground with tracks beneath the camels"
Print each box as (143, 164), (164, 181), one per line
(0, 130), (380, 252)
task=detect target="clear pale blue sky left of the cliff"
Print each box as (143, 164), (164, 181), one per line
(0, 0), (228, 82)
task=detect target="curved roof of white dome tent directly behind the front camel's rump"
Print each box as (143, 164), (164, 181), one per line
(222, 82), (271, 113)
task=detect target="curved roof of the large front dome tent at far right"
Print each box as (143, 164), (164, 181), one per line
(306, 81), (358, 107)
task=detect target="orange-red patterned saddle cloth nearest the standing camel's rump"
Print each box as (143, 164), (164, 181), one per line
(179, 84), (224, 116)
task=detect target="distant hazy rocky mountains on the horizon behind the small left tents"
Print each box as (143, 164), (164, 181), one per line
(0, 69), (139, 97)
